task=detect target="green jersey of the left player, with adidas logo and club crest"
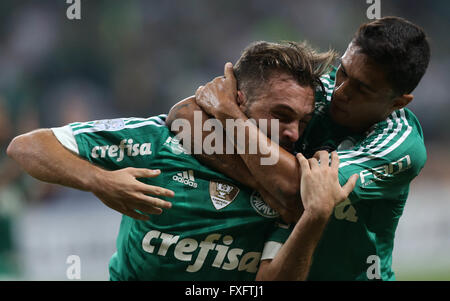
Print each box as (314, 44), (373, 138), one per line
(53, 115), (289, 280)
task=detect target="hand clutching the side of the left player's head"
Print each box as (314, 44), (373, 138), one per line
(195, 63), (241, 120)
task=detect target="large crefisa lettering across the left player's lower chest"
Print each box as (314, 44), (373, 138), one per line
(142, 230), (261, 273)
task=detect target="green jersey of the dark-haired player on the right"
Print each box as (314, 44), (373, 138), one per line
(296, 69), (427, 280)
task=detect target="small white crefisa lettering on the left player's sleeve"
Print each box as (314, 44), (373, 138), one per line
(91, 139), (152, 162)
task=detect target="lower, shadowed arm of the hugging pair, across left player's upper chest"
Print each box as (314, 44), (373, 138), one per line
(166, 97), (299, 222)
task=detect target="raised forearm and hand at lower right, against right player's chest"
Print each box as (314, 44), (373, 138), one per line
(256, 151), (358, 281)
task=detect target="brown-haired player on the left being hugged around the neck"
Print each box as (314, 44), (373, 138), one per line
(4, 43), (356, 280)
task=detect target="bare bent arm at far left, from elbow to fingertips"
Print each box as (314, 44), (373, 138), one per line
(7, 129), (173, 219)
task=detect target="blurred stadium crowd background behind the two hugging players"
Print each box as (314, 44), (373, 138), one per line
(0, 0), (450, 280)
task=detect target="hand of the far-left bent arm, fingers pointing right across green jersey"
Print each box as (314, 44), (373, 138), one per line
(91, 167), (174, 220)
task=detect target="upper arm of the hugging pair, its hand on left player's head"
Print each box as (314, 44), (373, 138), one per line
(196, 63), (300, 209)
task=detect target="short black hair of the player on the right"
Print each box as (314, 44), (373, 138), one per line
(352, 17), (430, 95)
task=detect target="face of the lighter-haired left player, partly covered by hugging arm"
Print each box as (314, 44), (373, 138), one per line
(243, 74), (314, 151)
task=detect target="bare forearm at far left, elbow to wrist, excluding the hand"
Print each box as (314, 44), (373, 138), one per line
(7, 129), (103, 191)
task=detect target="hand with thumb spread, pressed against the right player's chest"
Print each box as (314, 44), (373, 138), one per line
(297, 151), (358, 219)
